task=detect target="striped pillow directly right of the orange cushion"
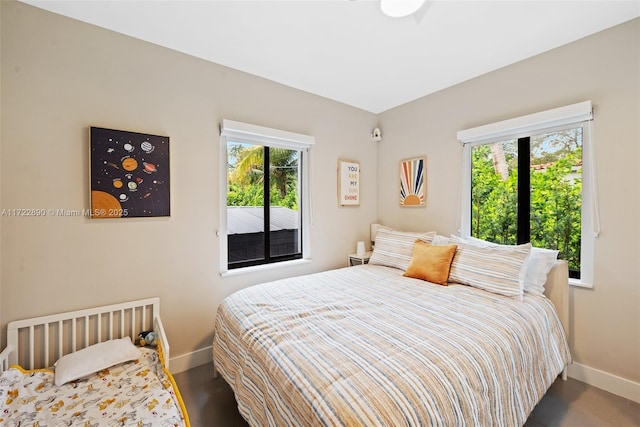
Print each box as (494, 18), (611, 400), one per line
(449, 236), (531, 298)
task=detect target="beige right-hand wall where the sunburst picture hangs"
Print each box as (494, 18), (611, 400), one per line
(378, 19), (640, 381)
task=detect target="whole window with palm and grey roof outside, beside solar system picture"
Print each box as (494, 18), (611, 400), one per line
(218, 120), (313, 272)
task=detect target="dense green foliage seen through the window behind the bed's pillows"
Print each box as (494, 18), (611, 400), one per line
(471, 129), (582, 271)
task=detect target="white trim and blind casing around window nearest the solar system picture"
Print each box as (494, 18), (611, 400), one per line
(216, 119), (315, 276)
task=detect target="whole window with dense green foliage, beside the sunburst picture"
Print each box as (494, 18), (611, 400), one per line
(458, 102), (597, 283)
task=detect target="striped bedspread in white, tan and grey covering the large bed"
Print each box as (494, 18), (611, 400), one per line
(213, 265), (570, 427)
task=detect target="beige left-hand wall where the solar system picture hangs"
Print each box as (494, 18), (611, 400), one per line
(0, 1), (377, 356)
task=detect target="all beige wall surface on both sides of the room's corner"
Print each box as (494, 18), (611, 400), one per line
(0, 1), (640, 388)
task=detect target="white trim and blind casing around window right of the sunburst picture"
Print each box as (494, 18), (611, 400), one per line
(457, 101), (600, 288)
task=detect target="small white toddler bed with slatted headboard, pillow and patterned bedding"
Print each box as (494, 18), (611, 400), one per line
(0, 298), (189, 427)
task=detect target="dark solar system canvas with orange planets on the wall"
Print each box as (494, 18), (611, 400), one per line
(91, 127), (170, 218)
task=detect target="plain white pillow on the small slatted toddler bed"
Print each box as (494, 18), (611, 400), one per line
(53, 337), (140, 386)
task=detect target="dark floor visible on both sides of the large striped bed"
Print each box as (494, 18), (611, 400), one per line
(174, 364), (640, 427)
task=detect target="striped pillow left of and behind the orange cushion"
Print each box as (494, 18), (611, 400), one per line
(369, 229), (436, 271)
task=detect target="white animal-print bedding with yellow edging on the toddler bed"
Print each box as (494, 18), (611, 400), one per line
(0, 347), (189, 427)
